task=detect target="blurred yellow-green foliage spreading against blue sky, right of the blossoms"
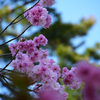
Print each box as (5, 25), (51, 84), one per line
(31, 17), (100, 69)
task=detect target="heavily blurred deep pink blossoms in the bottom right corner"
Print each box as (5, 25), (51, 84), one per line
(76, 61), (100, 100)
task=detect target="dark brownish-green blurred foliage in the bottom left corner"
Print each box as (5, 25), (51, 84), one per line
(0, 71), (34, 100)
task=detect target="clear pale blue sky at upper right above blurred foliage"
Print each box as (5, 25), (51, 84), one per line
(53, 0), (100, 53)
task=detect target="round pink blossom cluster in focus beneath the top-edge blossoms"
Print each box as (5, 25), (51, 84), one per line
(24, 3), (51, 29)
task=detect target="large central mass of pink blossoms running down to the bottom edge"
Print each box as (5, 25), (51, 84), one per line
(9, 34), (80, 100)
